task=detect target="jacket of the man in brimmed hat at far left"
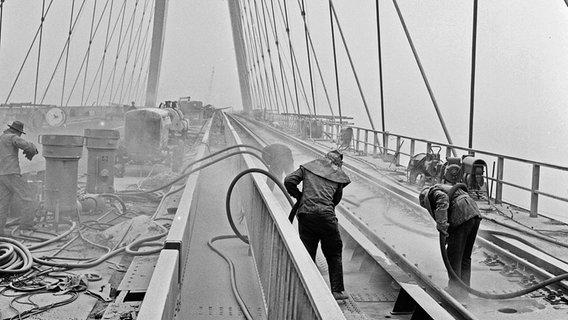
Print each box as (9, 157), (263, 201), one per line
(0, 129), (37, 176)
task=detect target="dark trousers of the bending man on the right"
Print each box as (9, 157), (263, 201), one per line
(447, 217), (481, 290)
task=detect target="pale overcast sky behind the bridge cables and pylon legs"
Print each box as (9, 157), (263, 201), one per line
(0, 0), (568, 164)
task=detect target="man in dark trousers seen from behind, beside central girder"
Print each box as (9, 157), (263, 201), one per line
(284, 150), (351, 300)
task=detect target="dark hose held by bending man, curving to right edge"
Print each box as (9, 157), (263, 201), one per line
(439, 183), (568, 300)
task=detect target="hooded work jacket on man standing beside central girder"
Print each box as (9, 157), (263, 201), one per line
(284, 159), (351, 216)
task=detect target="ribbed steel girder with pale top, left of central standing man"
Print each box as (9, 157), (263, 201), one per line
(221, 112), (345, 320)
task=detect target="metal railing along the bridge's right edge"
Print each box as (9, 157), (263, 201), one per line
(273, 115), (568, 217)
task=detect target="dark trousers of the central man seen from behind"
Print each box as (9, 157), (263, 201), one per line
(298, 214), (345, 292)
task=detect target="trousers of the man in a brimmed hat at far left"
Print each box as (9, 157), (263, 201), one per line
(0, 174), (34, 234)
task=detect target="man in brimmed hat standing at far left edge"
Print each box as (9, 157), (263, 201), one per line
(0, 121), (38, 235)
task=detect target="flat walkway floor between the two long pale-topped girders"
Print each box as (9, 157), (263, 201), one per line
(176, 149), (266, 320)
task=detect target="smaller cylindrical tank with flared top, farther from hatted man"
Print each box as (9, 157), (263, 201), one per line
(85, 129), (120, 193)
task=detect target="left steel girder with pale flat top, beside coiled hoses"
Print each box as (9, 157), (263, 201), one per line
(137, 120), (212, 320)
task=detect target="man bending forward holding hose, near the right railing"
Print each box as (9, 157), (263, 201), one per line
(419, 164), (481, 298)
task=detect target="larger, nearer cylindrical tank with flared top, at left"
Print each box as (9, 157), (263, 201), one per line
(40, 135), (83, 216)
